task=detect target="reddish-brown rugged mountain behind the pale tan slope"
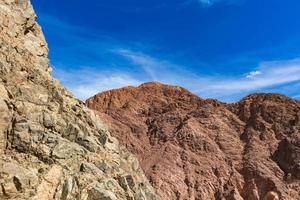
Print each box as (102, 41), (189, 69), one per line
(87, 83), (300, 200)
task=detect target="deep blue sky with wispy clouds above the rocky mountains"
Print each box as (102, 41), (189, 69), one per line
(32, 0), (300, 102)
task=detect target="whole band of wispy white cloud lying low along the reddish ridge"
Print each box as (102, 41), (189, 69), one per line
(55, 49), (300, 101)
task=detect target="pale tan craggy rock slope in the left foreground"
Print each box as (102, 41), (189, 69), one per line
(0, 0), (157, 200)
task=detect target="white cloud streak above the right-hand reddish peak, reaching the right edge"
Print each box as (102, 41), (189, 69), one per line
(200, 59), (300, 98)
